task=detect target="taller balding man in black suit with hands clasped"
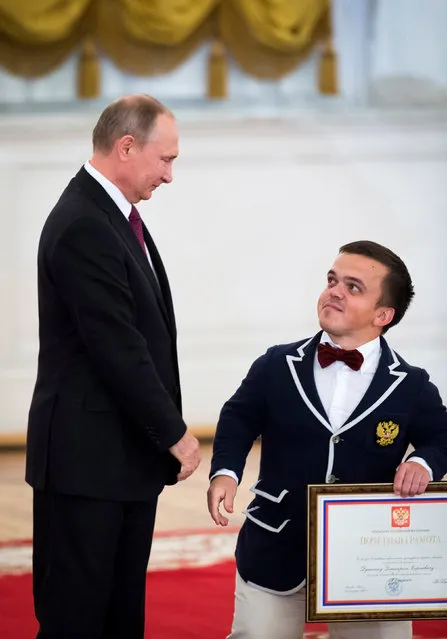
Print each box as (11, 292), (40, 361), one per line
(26, 95), (200, 639)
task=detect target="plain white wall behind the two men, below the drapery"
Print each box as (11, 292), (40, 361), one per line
(0, 111), (447, 439)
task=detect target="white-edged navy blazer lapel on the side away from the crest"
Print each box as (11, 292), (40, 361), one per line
(286, 331), (332, 432)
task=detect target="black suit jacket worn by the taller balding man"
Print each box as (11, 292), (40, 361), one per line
(26, 168), (186, 501)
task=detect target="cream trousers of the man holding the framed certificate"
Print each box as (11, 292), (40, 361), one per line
(227, 573), (413, 639)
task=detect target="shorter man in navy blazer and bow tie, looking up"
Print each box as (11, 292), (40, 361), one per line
(208, 241), (447, 639)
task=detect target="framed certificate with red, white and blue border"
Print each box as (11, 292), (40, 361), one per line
(307, 482), (447, 622)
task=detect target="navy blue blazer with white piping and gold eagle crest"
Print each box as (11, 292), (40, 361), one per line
(210, 332), (447, 594)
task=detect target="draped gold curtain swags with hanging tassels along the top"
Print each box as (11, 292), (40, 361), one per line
(0, 0), (336, 98)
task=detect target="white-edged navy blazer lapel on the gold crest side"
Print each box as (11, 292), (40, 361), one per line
(337, 337), (407, 433)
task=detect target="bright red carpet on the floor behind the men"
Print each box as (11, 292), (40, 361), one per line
(0, 561), (447, 639)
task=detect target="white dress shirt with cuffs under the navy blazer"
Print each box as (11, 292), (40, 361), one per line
(215, 331), (433, 483)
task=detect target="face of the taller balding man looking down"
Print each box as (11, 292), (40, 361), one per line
(125, 114), (178, 203)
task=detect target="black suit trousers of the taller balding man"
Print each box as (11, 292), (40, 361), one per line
(33, 490), (157, 639)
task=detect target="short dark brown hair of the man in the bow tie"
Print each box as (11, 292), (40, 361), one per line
(339, 240), (414, 333)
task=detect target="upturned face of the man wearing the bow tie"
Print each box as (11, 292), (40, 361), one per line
(317, 253), (394, 345)
